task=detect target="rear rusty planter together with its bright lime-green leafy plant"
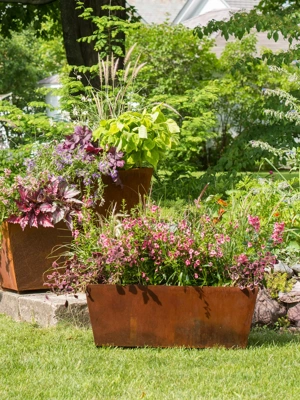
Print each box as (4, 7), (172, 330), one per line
(93, 106), (179, 212)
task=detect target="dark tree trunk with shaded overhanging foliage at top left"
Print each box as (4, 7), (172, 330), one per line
(0, 0), (126, 78)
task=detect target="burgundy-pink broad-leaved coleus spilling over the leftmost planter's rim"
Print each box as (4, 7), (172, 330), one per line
(7, 178), (82, 230)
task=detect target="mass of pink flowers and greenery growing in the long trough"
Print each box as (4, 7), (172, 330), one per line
(46, 198), (284, 293)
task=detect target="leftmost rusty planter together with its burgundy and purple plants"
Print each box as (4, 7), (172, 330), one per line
(0, 127), (124, 291)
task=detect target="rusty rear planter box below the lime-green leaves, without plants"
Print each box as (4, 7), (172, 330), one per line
(96, 168), (153, 215)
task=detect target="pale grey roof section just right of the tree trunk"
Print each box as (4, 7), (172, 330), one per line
(127, 0), (186, 24)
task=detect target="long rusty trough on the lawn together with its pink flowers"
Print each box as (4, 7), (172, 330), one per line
(47, 195), (283, 347)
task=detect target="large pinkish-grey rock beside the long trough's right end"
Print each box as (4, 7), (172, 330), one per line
(252, 288), (286, 325)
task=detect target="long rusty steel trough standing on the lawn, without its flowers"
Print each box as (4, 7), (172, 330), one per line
(87, 285), (257, 348)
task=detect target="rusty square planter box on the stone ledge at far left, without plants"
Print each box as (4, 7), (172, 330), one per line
(0, 222), (71, 292)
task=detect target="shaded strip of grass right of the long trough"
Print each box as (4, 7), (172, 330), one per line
(248, 328), (300, 348)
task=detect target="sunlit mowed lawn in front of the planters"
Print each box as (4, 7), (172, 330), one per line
(0, 315), (300, 400)
